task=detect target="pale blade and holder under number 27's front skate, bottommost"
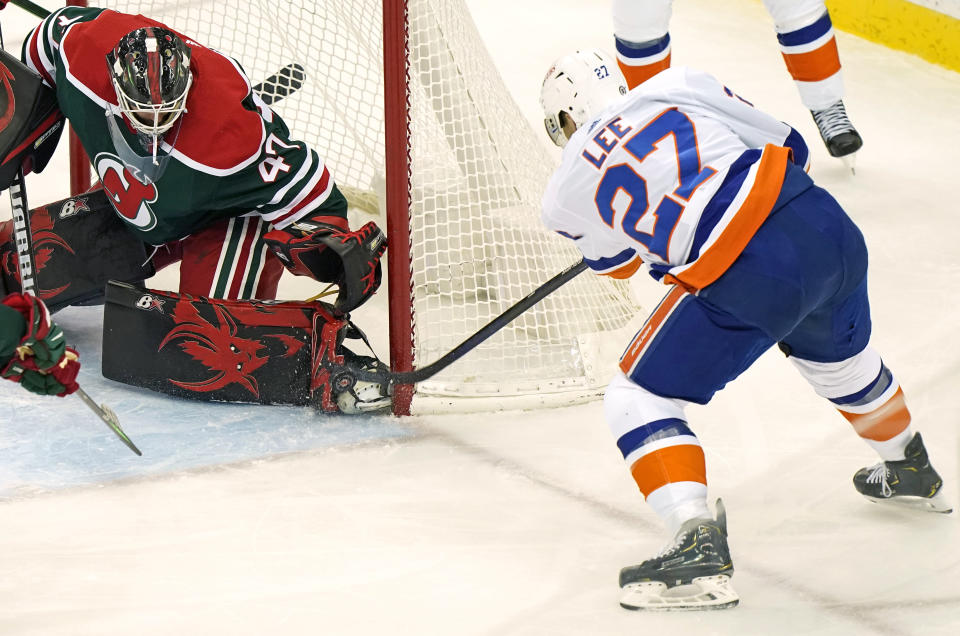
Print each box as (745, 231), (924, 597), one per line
(620, 574), (740, 612)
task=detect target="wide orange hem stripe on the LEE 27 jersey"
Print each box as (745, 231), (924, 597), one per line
(676, 144), (790, 289)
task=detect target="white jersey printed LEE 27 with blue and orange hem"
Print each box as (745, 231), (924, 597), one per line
(543, 67), (809, 289)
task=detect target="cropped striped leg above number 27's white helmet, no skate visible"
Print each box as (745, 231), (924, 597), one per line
(613, 0), (672, 88)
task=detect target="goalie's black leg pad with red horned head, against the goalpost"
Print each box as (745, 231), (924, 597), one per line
(103, 281), (391, 413)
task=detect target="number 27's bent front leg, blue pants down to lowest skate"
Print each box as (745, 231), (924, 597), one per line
(604, 287), (773, 610)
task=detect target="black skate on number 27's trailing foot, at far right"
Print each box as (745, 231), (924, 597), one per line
(853, 433), (953, 513)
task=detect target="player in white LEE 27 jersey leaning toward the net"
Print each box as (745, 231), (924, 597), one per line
(541, 50), (950, 609)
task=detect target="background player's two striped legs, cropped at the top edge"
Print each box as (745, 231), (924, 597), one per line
(613, 0), (863, 168)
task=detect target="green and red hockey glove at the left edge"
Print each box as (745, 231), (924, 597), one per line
(0, 294), (80, 397)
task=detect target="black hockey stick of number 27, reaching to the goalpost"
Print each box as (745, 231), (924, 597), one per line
(331, 259), (587, 389)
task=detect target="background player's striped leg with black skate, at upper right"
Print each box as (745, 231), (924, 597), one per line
(764, 0), (863, 157)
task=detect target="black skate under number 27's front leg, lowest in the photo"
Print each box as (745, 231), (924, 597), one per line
(620, 499), (740, 611)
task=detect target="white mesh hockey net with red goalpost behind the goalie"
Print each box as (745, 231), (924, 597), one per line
(75, 0), (642, 413)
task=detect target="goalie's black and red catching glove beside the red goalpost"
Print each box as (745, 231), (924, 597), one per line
(263, 217), (387, 313)
